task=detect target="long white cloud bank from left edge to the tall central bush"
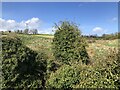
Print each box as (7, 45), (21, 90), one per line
(0, 17), (55, 34)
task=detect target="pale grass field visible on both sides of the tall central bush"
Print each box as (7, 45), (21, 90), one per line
(19, 35), (119, 57)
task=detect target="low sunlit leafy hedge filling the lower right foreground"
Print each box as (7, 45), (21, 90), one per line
(47, 47), (120, 89)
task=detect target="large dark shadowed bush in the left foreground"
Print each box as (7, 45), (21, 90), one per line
(2, 37), (47, 89)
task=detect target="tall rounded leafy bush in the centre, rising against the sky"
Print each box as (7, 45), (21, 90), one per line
(53, 21), (89, 64)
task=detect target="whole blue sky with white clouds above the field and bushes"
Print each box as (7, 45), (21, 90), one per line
(0, 2), (118, 35)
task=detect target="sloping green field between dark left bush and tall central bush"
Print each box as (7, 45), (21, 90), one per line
(19, 34), (53, 59)
